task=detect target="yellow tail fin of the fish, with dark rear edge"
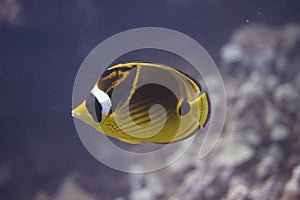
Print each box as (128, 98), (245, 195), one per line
(192, 93), (211, 127)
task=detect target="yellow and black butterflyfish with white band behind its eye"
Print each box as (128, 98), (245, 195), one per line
(72, 62), (210, 144)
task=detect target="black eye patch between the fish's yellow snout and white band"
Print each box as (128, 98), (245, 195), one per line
(85, 94), (102, 122)
